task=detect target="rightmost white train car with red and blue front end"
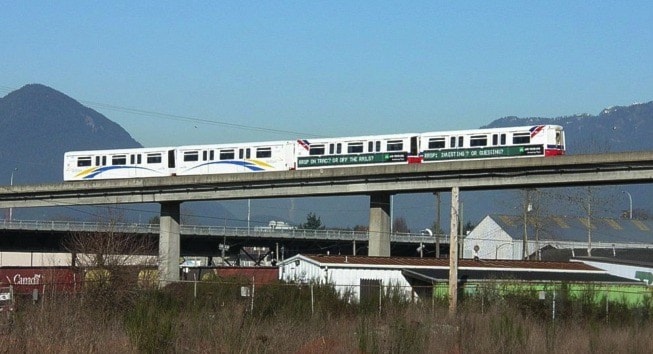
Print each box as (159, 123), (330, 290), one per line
(419, 125), (565, 162)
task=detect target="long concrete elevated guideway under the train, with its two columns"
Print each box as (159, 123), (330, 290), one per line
(0, 152), (653, 282)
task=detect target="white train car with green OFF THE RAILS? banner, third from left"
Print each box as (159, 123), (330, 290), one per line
(296, 133), (419, 169)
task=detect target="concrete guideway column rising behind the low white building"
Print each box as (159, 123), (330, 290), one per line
(367, 193), (390, 257)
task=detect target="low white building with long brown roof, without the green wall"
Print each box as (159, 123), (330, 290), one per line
(279, 254), (637, 300)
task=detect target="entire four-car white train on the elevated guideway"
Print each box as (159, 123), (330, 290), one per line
(63, 125), (565, 181)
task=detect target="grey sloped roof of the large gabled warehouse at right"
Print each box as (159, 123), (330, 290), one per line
(487, 215), (653, 244)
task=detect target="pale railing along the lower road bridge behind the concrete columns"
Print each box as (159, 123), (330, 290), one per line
(0, 220), (449, 244)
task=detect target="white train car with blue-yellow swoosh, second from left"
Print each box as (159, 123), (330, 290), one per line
(176, 141), (295, 176)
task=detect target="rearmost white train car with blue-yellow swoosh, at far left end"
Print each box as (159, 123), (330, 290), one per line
(63, 147), (175, 181)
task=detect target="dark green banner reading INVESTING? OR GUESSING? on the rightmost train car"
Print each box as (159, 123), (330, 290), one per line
(424, 145), (544, 161)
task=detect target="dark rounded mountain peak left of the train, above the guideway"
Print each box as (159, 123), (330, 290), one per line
(0, 84), (141, 184)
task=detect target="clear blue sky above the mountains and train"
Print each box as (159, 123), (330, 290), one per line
(0, 1), (653, 146)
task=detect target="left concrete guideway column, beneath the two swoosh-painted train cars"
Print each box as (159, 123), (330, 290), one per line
(159, 202), (181, 287)
